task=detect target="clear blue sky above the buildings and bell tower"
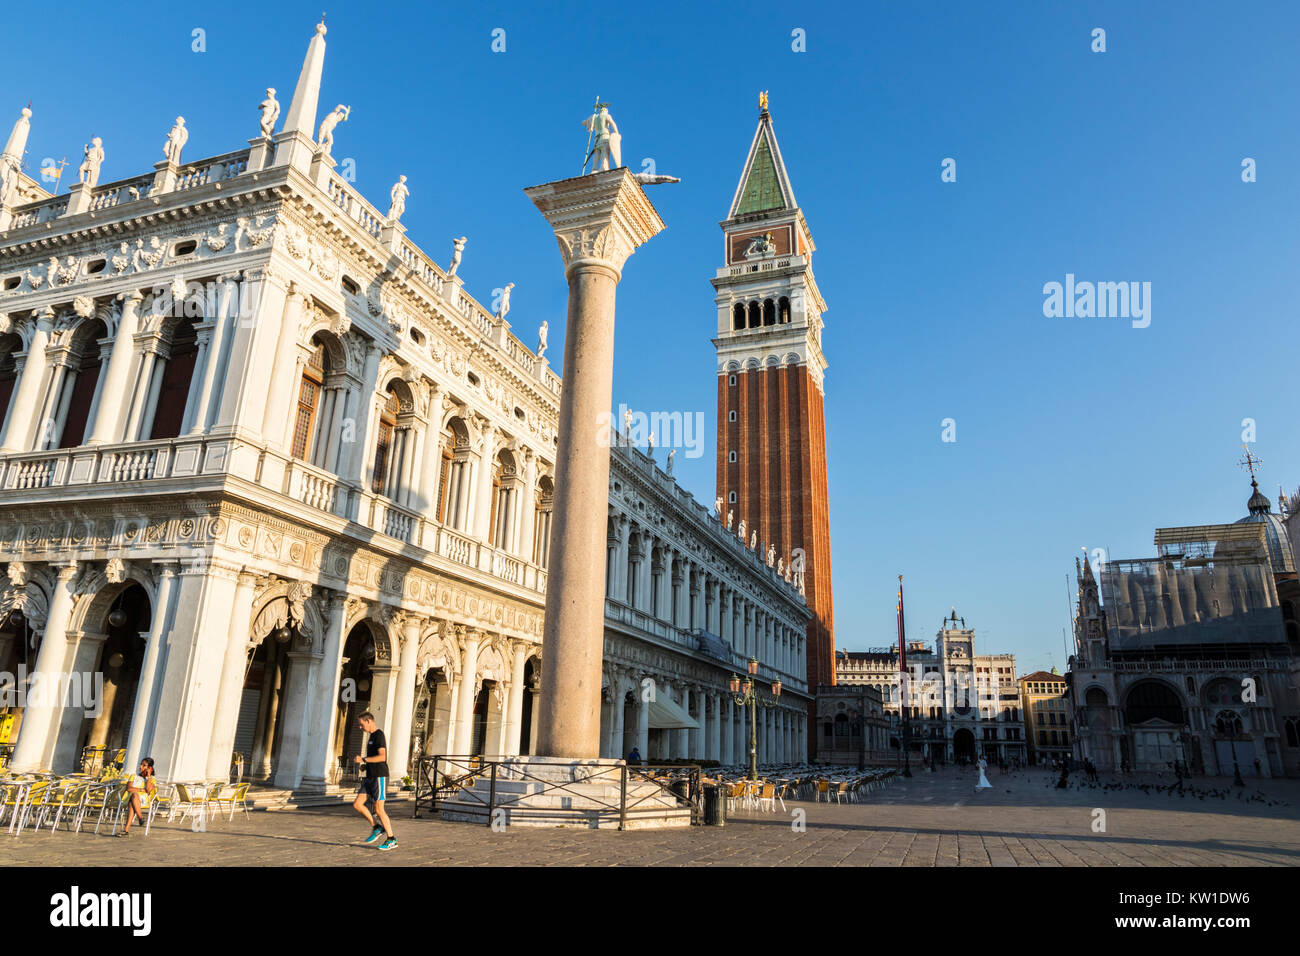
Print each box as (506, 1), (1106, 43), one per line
(0, 0), (1300, 672)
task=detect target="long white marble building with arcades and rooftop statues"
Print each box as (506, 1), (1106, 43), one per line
(0, 26), (807, 791)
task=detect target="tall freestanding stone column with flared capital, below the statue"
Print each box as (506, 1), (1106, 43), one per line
(525, 168), (663, 758)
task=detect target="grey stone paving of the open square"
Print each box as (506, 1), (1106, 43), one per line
(10, 769), (1300, 866)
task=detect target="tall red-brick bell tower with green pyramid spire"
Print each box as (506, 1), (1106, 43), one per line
(712, 92), (835, 753)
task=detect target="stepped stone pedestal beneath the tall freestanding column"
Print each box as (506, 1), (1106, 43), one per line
(439, 757), (690, 830)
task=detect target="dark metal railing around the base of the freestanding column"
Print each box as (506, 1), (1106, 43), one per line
(411, 754), (703, 830)
